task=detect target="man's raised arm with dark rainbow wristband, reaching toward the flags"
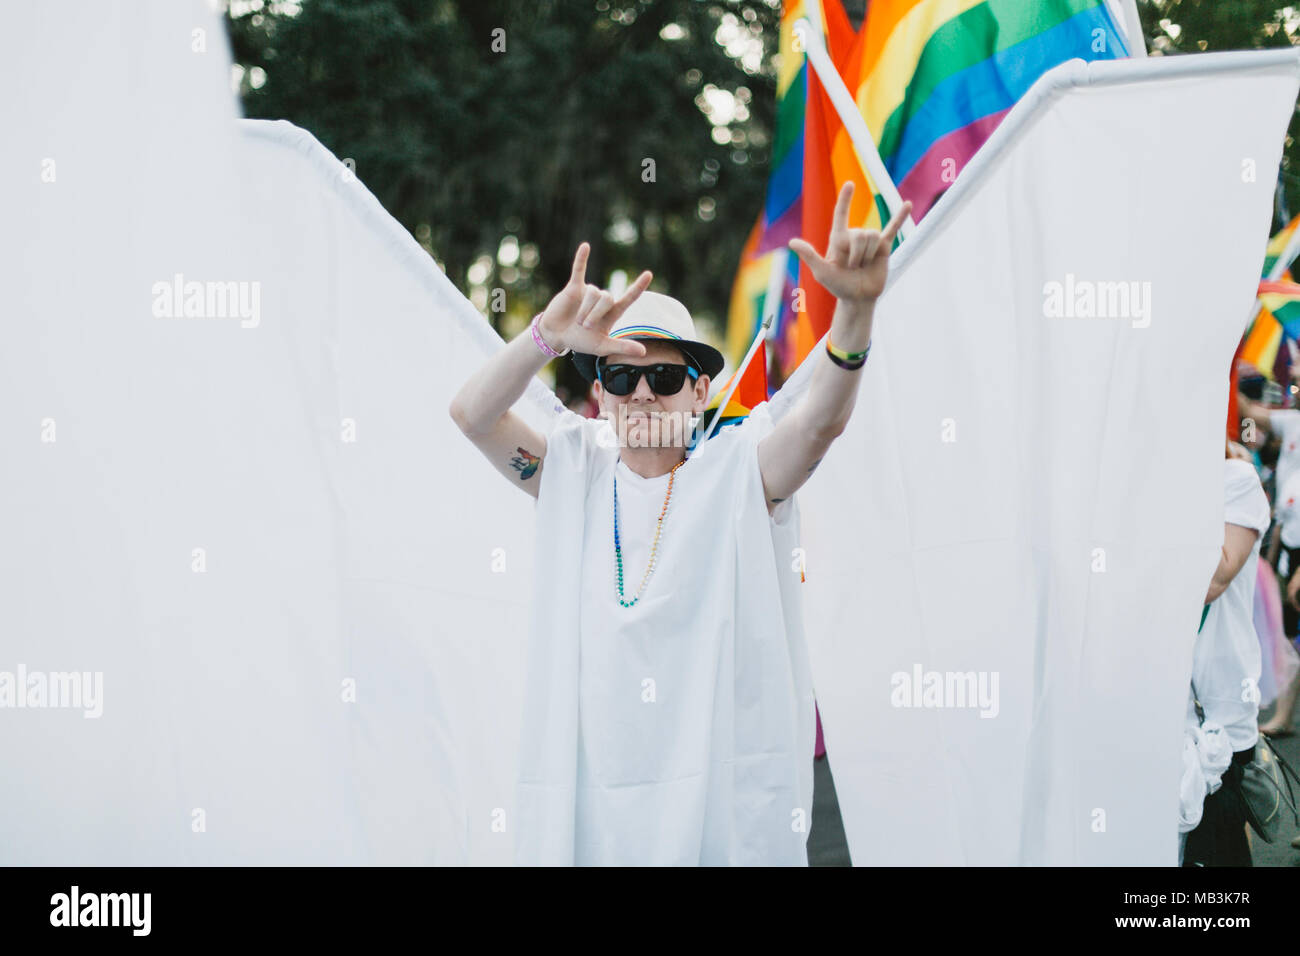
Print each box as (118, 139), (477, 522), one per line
(758, 182), (911, 514)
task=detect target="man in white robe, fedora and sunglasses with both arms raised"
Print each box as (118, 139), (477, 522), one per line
(450, 183), (910, 865)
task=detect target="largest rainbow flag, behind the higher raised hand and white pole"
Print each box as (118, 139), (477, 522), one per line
(781, 0), (1128, 371)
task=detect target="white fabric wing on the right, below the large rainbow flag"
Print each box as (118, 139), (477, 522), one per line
(772, 51), (1297, 865)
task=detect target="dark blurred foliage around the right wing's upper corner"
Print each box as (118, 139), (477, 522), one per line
(1138, 0), (1300, 225)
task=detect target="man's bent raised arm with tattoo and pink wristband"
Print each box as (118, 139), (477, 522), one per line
(449, 242), (650, 498)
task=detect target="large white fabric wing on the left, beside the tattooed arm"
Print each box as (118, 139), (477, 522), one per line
(0, 0), (555, 865)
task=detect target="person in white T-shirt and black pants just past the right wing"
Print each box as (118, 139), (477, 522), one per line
(1183, 444), (1269, 866)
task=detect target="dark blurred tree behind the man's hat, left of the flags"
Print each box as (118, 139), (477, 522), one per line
(228, 0), (780, 400)
